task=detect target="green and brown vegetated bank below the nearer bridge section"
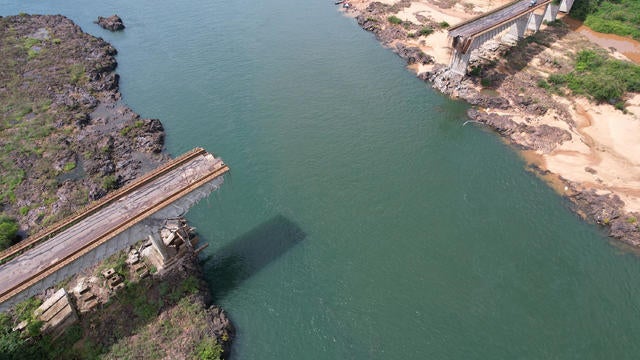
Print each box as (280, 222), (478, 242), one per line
(0, 256), (231, 360)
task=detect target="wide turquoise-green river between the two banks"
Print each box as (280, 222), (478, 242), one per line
(0, 0), (640, 359)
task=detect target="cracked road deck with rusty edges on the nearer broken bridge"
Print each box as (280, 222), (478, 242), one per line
(0, 149), (229, 302)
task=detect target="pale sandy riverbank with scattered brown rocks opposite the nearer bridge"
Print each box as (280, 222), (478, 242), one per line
(346, 0), (640, 245)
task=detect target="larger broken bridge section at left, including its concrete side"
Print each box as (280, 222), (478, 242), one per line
(0, 149), (229, 311)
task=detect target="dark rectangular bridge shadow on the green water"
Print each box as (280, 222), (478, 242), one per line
(203, 215), (307, 303)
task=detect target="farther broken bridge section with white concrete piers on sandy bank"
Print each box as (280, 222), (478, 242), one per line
(449, 0), (574, 75)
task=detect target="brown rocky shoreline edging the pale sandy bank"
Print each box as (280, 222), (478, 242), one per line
(346, 0), (640, 247)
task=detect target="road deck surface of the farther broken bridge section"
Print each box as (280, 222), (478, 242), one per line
(449, 0), (552, 38)
